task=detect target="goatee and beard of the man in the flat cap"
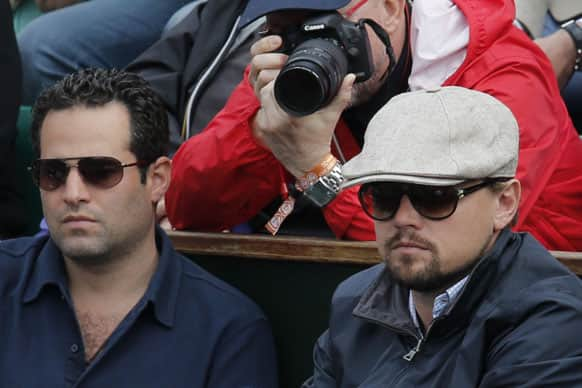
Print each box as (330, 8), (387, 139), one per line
(384, 230), (490, 292)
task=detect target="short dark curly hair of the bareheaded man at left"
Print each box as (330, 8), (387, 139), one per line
(31, 69), (169, 182)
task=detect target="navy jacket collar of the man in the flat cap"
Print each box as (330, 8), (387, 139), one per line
(352, 229), (517, 336)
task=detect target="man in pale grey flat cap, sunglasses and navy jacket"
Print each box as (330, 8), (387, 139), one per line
(304, 87), (582, 388)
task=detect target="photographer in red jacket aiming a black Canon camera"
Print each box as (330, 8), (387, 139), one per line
(160, 0), (582, 250)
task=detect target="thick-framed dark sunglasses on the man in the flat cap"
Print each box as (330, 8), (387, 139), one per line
(358, 179), (502, 221)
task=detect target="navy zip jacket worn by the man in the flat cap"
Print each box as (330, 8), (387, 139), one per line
(305, 231), (582, 388)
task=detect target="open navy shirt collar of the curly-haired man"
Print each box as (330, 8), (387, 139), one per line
(22, 227), (182, 327)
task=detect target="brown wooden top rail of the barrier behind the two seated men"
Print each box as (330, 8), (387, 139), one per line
(169, 231), (582, 276)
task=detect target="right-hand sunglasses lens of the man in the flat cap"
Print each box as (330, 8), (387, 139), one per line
(409, 187), (458, 220)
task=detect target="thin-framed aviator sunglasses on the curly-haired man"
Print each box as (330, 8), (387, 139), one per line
(28, 156), (145, 191)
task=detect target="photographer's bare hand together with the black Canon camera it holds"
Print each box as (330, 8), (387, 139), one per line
(249, 12), (373, 176)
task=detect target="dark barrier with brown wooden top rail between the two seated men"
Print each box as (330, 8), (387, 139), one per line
(170, 232), (582, 388)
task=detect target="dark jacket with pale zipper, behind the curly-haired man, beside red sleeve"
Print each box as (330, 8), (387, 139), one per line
(127, 0), (256, 150)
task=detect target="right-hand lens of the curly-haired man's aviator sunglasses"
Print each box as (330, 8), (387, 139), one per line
(79, 157), (123, 189)
